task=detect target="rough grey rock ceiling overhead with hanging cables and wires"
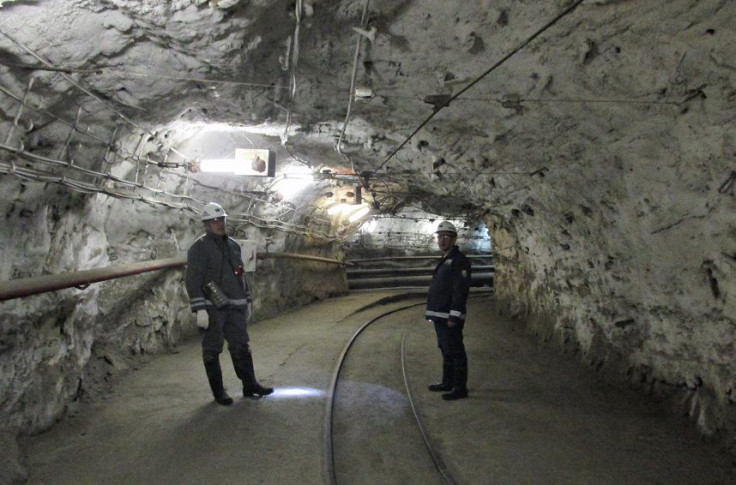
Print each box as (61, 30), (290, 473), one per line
(0, 0), (736, 227)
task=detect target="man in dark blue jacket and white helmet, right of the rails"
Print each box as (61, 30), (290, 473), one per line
(426, 221), (470, 401)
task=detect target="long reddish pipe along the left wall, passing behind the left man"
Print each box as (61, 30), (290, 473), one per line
(0, 253), (345, 301)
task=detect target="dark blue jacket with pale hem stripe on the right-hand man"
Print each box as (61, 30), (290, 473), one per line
(426, 246), (470, 322)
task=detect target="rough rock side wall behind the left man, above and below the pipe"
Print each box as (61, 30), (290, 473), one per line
(0, 184), (347, 442)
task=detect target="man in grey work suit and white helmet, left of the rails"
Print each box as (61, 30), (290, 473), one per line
(186, 202), (273, 406)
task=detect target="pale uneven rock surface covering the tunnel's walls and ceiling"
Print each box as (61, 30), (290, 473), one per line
(0, 0), (736, 460)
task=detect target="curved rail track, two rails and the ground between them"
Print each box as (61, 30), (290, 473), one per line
(324, 302), (456, 485)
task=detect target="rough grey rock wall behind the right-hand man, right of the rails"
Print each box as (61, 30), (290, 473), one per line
(488, 182), (736, 450)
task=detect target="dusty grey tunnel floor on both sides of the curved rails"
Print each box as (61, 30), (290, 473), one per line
(21, 291), (736, 484)
